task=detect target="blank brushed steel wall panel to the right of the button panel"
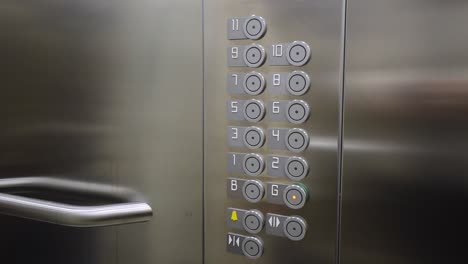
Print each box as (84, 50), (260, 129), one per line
(341, 0), (468, 264)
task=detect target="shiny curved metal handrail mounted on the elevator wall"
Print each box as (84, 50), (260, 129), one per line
(0, 177), (153, 227)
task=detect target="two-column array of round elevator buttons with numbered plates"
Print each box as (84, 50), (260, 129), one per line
(226, 15), (313, 259)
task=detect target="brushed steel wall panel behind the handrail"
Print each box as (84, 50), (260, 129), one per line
(0, 0), (203, 264)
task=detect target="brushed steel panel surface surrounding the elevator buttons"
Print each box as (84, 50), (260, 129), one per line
(204, 0), (344, 264)
